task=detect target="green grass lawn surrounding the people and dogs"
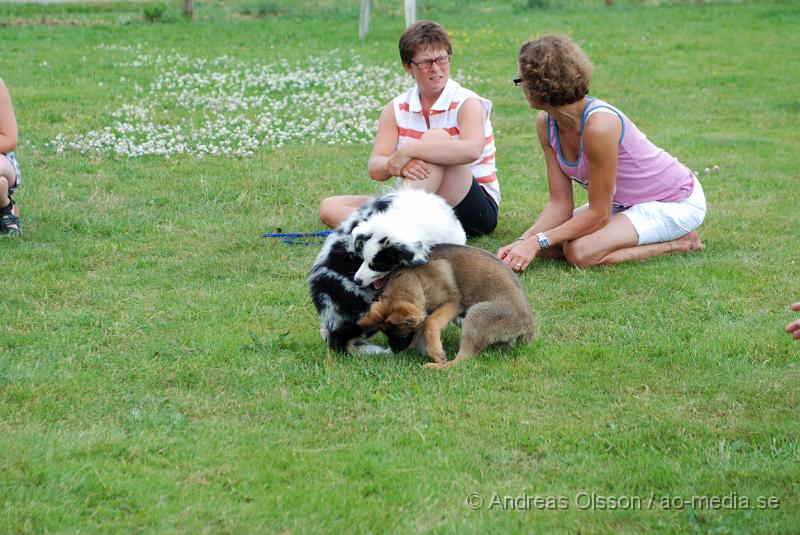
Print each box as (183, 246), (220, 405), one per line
(0, 0), (800, 534)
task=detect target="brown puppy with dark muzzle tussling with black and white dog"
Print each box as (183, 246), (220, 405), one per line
(358, 245), (536, 369)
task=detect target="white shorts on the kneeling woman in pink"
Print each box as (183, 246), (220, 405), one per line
(619, 178), (706, 245)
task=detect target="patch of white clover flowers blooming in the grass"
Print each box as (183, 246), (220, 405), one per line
(51, 49), (416, 158)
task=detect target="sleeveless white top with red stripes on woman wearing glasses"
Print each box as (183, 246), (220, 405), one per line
(392, 79), (500, 206)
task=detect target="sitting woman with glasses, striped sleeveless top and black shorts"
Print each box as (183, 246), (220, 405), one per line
(319, 21), (500, 236)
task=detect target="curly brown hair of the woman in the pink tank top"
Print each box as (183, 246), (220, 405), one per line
(519, 35), (594, 106)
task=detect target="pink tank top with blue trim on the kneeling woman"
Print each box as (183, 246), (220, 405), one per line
(547, 99), (695, 209)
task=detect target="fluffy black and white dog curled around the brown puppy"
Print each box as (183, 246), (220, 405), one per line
(308, 190), (467, 353)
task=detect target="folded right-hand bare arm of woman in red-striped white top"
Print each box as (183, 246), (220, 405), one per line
(389, 98), (486, 173)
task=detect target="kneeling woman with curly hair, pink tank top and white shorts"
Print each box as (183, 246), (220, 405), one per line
(497, 35), (706, 272)
